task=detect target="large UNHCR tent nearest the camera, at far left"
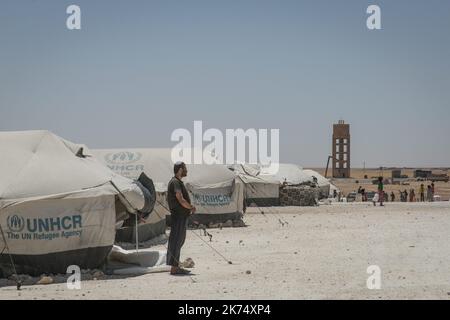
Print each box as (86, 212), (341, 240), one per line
(0, 131), (145, 274)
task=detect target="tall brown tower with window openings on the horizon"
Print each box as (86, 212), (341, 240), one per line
(333, 120), (350, 178)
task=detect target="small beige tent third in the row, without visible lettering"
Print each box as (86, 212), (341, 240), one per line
(228, 164), (280, 207)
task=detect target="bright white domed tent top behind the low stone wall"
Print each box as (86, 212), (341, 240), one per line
(259, 163), (314, 185)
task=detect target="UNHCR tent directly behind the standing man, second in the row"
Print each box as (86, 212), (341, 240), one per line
(94, 148), (244, 231)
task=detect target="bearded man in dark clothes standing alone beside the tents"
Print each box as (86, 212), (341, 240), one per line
(167, 161), (196, 275)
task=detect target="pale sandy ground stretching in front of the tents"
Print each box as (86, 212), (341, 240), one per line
(0, 202), (450, 300)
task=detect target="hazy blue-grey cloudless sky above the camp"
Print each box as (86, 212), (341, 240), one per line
(0, 0), (450, 167)
